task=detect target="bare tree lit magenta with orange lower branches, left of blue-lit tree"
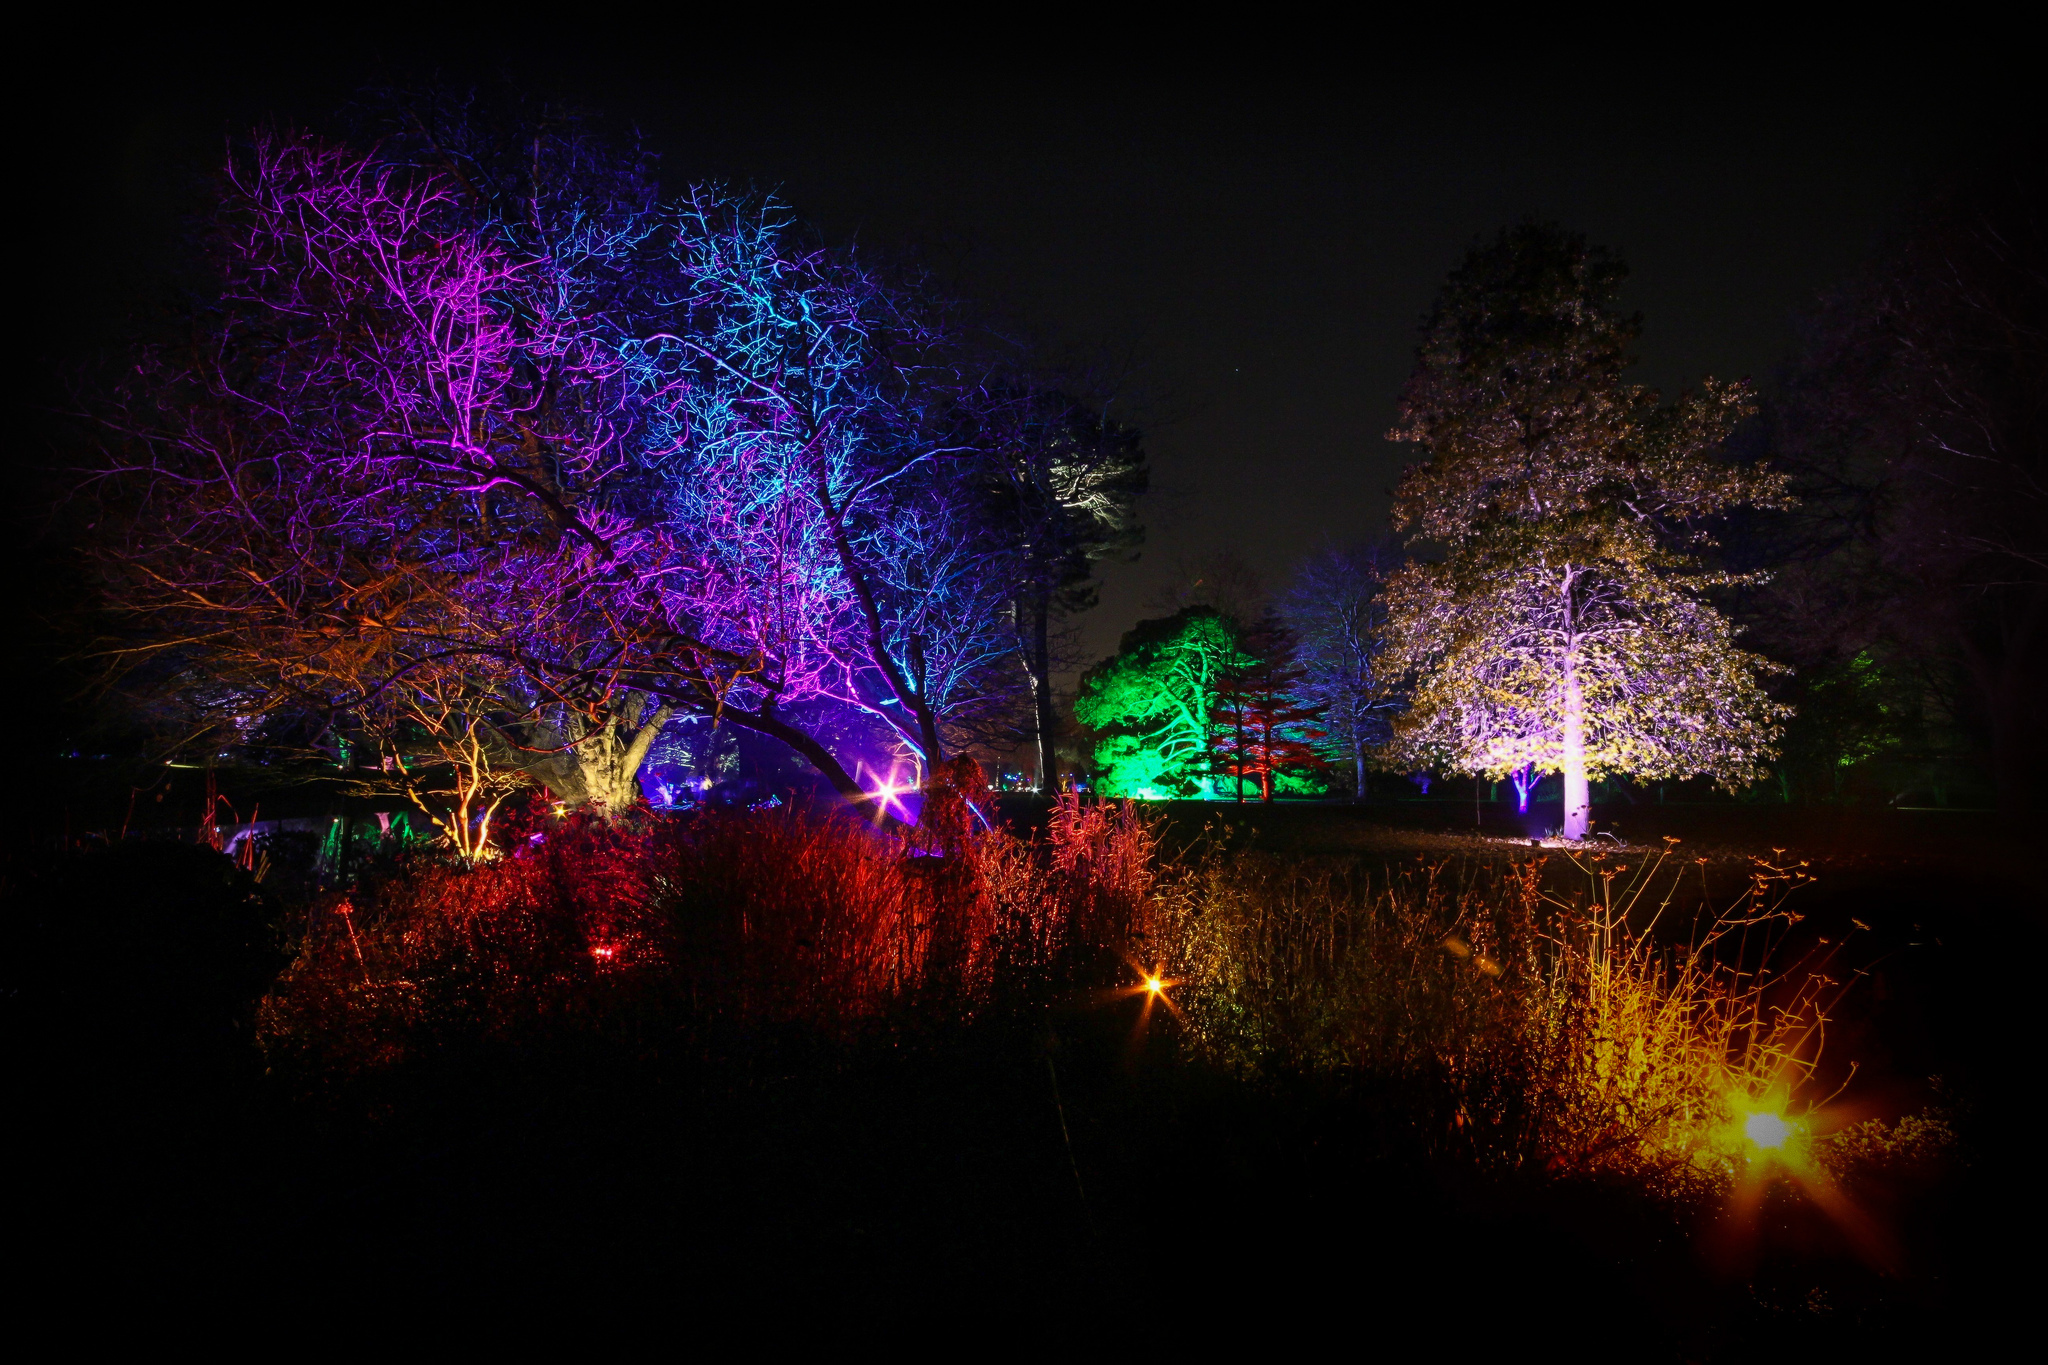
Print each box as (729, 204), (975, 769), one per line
(88, 130), (704, 822)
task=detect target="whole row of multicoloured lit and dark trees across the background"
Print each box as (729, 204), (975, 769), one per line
(72, 92), (2048, 857)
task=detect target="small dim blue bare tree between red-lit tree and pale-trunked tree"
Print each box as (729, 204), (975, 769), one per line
(1280, 544), (1401, 800)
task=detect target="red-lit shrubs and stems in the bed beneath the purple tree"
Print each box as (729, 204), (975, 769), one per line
(262, 789), (1153, 1072)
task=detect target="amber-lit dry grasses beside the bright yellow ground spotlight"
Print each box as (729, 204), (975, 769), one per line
(1159, 851), (1875, 1193)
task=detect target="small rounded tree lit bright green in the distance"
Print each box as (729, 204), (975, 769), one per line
(1073, 606), (1251, 798)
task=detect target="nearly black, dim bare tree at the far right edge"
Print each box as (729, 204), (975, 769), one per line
(1757, 165), (2048, 810)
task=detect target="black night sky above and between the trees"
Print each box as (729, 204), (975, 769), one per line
(33, 43), (2019, 671)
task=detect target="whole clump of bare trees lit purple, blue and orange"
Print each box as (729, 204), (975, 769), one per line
(88, 100), (1105, 826)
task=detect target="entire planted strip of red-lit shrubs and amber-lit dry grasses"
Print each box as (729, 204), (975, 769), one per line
(262, 782), (1925, 1195)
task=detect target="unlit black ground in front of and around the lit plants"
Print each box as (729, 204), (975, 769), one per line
(6, 808), (2040, 1359)
